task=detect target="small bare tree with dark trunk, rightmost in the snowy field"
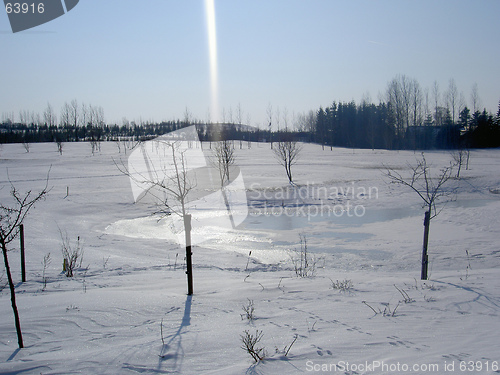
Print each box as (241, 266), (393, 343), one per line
(386, 153), (455, 280)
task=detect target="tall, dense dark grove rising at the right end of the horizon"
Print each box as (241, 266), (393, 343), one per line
(308, 75), (500, 149)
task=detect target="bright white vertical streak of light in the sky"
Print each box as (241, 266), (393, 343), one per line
(205, 0), (219, 122)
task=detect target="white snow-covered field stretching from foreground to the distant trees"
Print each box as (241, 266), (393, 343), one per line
(0, 143), (500, 374)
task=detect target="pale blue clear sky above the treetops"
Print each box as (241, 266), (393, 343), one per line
(0, 0), (500, 127)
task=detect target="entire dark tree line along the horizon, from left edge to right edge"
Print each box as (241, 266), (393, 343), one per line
(0, 75), (500, 149)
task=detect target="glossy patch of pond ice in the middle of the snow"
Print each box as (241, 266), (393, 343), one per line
(106, 199), (492, 262)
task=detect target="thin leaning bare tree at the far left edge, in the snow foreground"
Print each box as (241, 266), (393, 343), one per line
(0, 181), (47, 348)
